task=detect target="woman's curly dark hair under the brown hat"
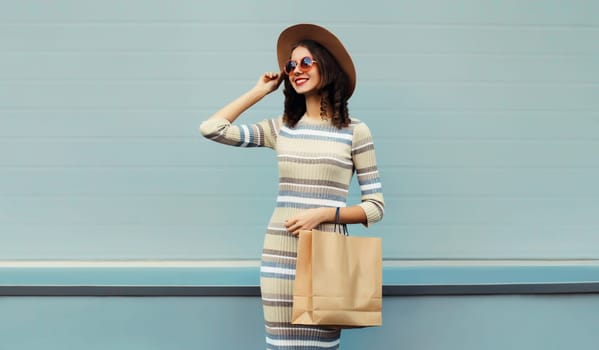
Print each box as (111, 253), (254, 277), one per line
(283, 40), (351, 129)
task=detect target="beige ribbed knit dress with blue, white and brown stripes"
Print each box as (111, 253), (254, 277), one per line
(200, 117), (384, 350)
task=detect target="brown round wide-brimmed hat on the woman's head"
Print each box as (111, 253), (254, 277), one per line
(277, 23), (356, 96)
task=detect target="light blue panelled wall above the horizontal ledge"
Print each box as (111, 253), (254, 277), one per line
(0, 0), (599, 259)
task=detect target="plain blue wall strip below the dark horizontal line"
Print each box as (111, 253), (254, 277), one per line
(0, 295), (599, 350)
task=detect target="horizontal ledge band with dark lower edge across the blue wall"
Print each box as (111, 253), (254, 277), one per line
(0, 260), (599, 296)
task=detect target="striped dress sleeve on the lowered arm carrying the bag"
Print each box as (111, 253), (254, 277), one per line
(352, 122), (385, 226)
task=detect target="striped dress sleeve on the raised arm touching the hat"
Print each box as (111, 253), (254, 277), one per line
(200, 118), (281, 148)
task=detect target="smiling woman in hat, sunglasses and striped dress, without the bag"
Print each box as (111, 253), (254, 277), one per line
(200, 24), (384, 349)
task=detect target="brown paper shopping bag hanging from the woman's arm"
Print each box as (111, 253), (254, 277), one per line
(291, 230), (382, 328)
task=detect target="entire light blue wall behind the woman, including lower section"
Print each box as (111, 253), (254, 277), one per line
(0, 0), (599, 350)
